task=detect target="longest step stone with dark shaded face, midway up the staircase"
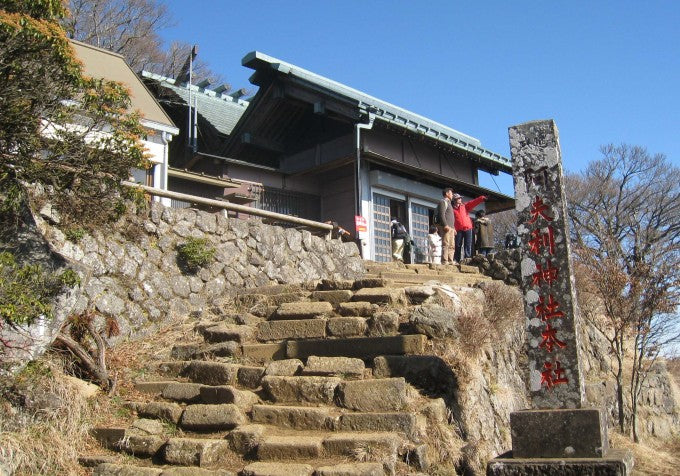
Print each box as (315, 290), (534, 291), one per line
(286, 334), (427, 359)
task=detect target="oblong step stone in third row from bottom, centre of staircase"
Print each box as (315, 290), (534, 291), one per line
(252, 405), (337, 430)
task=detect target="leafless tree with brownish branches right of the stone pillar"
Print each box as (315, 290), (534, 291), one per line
(567, 145), (680, 442)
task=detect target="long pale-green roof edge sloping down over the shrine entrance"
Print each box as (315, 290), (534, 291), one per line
(241, 51), (512, 173)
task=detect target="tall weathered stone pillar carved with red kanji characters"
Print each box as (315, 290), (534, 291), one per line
(509, 120), (584, 409)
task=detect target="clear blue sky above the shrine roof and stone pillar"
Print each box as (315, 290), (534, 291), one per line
(161, 0), (680, 194)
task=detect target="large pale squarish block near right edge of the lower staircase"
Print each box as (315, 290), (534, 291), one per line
(337, 377), (407, 412)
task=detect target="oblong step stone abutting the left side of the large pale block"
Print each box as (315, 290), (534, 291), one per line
(262, 376), (341, 405)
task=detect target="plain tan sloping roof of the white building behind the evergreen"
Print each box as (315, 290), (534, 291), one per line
(70, 40), (179, 134)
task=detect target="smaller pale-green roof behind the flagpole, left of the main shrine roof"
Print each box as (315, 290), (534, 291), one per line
(142, 71), (248, 135)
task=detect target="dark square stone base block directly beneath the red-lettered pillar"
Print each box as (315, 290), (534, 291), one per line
(510, 408), (608, 458)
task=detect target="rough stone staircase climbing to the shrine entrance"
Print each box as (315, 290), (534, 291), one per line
(81, 263), (487, 476)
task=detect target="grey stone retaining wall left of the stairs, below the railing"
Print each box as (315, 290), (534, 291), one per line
(2, 203), (364, 368)
